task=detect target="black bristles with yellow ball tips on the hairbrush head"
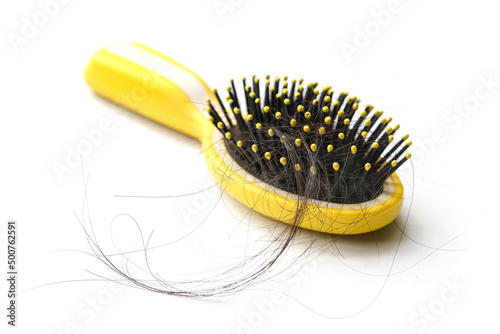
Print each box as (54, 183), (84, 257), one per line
(207, 76), (411, 204)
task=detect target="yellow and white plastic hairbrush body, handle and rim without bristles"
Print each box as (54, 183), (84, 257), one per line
(85, 43), (403, 234)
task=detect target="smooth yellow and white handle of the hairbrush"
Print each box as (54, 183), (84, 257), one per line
(84, 43), (214, 140)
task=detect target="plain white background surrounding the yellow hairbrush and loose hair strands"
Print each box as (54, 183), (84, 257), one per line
(0, 0), (500, 334)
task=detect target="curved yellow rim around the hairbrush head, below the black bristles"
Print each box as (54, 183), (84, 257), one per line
(203, 131), (404, 234)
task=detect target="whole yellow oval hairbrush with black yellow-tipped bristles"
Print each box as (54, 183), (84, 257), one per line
(85, 43), (411, 234)
